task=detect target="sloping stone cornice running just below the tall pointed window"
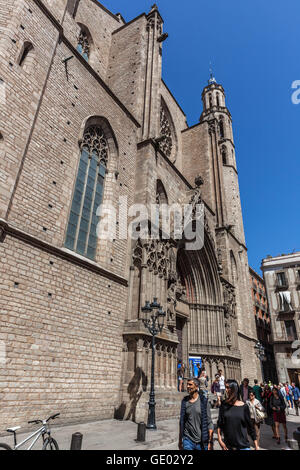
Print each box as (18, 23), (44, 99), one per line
(0, 219), (128, 287)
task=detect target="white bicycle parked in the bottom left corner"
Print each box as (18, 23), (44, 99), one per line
(0, 413), (60, 450)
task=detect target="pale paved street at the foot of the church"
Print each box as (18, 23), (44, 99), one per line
(0, 408), (300, 450)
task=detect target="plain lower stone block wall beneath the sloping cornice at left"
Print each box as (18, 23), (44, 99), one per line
(0, 235), (126, 431)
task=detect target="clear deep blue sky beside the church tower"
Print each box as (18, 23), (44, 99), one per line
(101, 0), (300, 273)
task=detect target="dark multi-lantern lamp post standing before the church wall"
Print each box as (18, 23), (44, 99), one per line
(142, 297), (166, 431)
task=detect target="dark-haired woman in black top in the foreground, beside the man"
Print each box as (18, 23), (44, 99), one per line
(218, 380), (259, 450)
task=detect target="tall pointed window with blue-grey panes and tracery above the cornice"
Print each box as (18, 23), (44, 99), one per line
(65, 126), (108, 259)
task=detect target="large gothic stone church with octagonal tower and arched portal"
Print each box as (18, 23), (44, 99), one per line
(0, 0), (260, 430)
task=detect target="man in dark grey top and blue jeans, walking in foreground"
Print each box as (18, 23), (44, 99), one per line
(178, 377), (214, 450)
